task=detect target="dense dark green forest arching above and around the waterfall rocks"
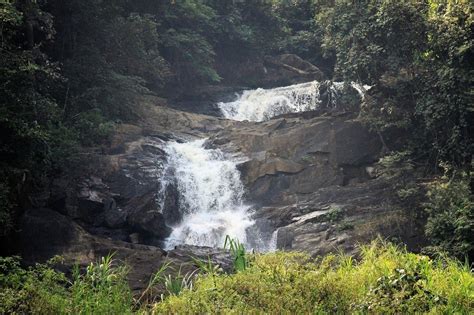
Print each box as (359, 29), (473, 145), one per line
(0, 0), (474, 312)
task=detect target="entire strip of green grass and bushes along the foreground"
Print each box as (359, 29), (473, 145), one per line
(0, 241), (474, 314)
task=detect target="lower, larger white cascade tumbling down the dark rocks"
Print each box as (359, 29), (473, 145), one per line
(161, 139), (254, 249)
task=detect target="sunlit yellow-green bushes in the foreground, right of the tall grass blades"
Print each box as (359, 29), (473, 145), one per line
(154, 242), (474, 314)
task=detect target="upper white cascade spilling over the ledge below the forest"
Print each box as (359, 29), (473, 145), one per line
(217, 81), (370, 121)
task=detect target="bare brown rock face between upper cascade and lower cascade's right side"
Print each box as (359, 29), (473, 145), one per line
(212, 117), (382, 203)
